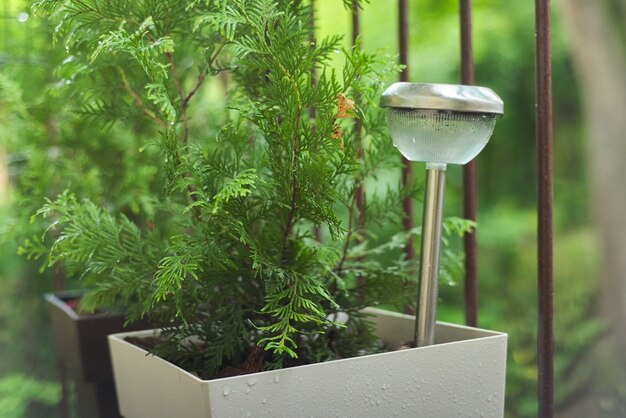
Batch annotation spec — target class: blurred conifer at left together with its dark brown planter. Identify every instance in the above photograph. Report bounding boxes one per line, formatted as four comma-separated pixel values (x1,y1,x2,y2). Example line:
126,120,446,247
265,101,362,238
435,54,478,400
0,5,161,417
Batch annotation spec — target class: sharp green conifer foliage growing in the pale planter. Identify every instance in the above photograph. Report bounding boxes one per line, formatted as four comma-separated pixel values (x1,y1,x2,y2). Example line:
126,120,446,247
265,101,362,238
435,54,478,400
26,0,471,376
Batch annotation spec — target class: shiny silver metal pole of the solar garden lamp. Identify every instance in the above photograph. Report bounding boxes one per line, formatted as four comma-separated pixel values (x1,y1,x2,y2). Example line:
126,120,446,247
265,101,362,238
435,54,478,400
415,163,446,347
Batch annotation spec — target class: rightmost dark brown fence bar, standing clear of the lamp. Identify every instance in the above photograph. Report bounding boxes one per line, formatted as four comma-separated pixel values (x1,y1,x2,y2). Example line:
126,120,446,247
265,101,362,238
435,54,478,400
535,0,554,418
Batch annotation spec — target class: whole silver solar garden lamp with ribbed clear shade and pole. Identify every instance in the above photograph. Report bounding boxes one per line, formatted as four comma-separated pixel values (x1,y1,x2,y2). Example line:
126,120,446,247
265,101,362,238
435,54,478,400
380,83,504,347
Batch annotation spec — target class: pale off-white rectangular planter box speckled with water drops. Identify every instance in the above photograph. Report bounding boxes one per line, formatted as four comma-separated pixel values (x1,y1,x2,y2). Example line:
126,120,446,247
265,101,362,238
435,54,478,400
109,309,507,418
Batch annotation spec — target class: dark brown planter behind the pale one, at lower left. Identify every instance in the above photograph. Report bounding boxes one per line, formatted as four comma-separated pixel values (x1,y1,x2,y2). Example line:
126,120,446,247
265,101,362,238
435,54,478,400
45,291,149,418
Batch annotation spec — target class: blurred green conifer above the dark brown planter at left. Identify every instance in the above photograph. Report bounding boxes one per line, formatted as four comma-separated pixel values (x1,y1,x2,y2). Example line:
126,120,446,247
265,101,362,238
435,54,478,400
0,8,161,288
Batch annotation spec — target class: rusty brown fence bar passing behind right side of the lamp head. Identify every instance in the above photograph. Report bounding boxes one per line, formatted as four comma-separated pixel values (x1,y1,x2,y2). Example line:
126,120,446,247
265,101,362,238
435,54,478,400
459,0,478,327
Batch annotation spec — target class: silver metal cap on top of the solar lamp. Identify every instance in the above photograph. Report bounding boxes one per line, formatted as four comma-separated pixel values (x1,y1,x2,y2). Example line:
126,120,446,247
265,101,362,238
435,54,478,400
380,82,504,115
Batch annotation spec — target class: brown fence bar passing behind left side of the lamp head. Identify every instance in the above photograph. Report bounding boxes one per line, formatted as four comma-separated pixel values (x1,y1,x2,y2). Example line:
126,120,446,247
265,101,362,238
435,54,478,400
398,0,415,259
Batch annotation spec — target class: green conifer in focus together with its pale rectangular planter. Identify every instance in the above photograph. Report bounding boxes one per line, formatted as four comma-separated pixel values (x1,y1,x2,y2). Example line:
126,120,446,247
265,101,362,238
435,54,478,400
30,0,506,417
